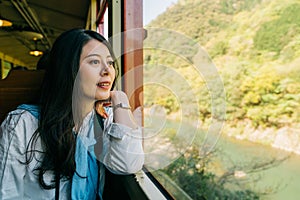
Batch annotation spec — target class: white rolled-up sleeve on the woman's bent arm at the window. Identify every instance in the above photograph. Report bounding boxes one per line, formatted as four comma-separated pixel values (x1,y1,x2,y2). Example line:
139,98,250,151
104,123,144,174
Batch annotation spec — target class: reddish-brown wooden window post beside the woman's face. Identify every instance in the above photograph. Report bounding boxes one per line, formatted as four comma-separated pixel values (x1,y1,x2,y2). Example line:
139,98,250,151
123,0,144,108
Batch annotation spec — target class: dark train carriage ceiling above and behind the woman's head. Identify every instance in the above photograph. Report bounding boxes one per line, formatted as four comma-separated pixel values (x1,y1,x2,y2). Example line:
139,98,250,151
0,0,91,67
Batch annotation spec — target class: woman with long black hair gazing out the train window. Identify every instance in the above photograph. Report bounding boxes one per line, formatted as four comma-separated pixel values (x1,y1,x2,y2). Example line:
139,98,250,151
0,29,144,199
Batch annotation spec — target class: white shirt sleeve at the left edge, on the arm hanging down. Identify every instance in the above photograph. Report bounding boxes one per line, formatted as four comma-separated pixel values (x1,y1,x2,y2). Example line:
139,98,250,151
0,113,26,199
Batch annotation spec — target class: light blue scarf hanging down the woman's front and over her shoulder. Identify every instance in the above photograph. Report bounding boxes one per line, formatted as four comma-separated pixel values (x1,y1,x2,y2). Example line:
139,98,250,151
17,104,104,200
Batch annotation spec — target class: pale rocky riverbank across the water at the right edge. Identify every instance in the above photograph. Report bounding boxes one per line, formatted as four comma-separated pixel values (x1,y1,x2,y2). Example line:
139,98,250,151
223,121,300,155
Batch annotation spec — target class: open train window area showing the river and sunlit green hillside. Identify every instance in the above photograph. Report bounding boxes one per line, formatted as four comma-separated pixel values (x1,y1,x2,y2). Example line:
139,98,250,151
143,0,300,199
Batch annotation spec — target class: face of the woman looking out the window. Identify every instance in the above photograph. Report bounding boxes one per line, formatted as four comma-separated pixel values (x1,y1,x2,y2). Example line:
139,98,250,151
79,39,116,100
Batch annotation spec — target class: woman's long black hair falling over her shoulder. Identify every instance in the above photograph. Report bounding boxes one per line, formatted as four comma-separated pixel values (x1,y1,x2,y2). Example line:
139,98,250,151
26,29,117,189
